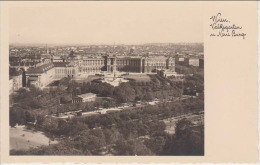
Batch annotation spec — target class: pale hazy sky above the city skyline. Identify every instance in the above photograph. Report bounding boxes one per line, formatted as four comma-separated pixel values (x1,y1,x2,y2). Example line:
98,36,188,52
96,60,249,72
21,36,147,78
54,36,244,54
9,1,203,44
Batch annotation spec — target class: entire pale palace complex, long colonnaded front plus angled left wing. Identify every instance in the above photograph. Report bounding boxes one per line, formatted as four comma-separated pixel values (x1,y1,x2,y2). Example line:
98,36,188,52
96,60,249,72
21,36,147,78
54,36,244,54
22,55,175,88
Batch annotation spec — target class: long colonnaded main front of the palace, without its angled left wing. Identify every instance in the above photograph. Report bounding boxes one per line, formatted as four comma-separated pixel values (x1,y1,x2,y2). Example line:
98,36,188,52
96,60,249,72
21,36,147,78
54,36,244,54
77,56,175,73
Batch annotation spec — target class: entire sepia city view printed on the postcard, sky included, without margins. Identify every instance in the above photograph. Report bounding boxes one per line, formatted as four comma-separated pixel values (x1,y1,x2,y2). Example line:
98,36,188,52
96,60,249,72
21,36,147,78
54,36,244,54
8,1,206,157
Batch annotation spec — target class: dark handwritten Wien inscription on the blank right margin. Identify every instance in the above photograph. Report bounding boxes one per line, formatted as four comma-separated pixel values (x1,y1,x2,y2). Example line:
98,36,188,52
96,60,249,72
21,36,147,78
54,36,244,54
210,13,246,39
